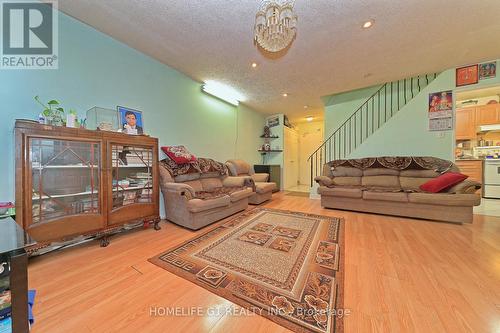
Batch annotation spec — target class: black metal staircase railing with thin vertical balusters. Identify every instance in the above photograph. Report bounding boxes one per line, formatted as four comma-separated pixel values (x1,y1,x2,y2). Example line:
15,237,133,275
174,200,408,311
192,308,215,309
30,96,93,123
307,73,438,187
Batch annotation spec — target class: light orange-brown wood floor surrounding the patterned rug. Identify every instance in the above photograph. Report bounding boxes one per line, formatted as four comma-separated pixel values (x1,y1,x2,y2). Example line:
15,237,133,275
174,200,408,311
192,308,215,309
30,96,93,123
29,194,500,333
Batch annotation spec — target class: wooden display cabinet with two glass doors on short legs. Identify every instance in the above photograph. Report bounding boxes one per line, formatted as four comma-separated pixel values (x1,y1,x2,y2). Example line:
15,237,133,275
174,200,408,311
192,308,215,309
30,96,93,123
15,120,160,246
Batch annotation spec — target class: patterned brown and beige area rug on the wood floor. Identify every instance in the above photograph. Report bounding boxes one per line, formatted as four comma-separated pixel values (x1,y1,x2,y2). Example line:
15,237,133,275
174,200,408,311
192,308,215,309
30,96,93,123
150,208,344,332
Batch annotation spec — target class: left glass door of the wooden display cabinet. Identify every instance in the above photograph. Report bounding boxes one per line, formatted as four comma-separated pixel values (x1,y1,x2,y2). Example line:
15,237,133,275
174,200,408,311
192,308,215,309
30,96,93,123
29,138,102,225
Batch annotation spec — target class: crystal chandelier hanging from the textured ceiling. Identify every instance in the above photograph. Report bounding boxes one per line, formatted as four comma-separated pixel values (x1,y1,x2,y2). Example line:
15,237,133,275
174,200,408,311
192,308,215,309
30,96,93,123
254,0,297,52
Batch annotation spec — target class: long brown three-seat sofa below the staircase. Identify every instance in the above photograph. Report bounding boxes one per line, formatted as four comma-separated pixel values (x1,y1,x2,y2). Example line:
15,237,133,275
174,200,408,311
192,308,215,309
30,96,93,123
315,156,481,223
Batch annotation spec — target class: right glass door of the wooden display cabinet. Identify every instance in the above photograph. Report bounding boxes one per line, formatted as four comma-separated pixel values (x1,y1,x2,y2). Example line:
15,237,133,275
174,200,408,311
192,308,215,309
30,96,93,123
111,144,153,211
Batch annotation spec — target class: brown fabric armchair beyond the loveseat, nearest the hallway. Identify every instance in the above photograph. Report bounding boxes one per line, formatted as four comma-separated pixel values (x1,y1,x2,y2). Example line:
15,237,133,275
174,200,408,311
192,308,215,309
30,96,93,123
226,159,276,205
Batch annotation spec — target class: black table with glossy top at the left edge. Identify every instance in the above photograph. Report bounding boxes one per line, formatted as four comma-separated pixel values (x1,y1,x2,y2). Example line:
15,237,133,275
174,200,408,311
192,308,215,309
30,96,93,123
0,217,29,333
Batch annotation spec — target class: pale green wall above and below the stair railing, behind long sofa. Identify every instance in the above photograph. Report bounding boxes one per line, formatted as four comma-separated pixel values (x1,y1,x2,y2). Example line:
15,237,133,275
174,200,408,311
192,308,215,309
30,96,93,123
325,62,500,160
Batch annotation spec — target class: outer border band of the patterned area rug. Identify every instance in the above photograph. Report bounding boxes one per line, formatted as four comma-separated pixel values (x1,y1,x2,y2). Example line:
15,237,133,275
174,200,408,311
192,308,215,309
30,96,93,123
148,207,345,333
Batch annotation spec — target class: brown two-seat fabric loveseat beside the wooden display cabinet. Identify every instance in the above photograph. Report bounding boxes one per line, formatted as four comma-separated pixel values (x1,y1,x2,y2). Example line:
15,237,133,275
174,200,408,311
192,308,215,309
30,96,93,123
159,158,253,230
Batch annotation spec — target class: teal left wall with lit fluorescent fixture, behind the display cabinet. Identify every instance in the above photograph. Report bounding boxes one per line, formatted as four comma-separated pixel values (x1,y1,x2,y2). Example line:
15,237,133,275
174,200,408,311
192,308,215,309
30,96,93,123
0,14,265,213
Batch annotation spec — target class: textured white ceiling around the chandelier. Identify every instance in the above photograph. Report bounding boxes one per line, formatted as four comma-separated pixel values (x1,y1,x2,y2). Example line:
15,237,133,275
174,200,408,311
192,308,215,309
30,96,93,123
59,0,500,121
